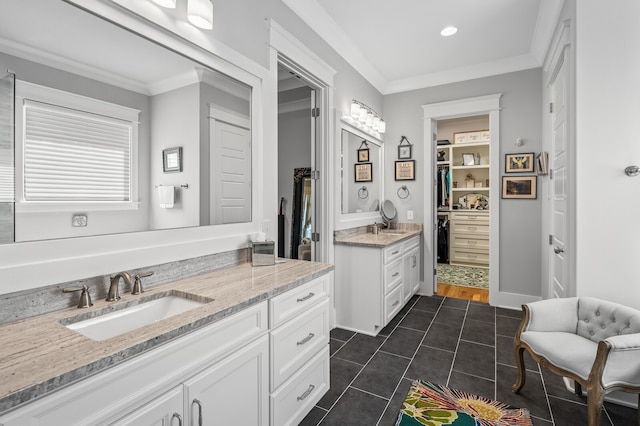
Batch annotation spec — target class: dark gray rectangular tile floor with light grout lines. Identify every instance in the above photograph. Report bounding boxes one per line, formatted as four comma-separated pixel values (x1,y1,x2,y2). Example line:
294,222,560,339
301,296,637,426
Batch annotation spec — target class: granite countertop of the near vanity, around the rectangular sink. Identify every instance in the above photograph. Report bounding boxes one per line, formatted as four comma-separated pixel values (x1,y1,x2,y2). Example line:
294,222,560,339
0,259,333,413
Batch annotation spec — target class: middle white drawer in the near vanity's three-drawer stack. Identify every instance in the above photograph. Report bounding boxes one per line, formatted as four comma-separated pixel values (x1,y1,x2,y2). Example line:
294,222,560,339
270,298,329,391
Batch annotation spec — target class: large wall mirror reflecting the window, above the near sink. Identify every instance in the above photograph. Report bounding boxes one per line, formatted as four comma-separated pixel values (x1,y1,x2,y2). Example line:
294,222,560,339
0,0,252,243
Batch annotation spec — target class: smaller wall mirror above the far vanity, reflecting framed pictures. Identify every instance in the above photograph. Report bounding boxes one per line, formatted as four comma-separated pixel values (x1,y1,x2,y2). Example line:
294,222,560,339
339,118,384,227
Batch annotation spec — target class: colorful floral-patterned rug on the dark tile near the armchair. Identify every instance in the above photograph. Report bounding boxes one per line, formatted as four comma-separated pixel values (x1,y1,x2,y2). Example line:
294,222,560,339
396,380,532,426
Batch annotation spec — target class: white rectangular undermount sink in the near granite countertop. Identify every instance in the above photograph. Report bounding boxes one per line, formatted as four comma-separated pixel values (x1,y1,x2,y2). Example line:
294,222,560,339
61,291,213,341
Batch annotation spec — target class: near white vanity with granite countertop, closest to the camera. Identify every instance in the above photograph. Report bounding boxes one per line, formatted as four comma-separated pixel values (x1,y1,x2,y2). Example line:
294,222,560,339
0,260,333,426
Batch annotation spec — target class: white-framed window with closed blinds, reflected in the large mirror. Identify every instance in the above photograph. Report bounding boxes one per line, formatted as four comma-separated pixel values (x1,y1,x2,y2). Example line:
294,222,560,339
16,81,139,210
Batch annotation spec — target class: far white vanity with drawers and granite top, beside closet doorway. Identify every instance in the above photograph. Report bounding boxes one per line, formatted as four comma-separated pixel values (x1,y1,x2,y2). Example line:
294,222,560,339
335,227,422,336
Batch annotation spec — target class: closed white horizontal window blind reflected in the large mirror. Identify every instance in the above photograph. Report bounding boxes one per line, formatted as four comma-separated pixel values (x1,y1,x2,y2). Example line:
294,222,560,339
23,99,132,202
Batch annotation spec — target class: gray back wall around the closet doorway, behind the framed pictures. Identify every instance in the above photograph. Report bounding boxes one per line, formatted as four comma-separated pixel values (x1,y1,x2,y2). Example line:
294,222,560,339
384,69,542,296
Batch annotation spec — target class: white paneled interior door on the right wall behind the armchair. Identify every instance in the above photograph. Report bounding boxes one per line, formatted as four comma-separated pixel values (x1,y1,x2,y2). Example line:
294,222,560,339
549,57,573,297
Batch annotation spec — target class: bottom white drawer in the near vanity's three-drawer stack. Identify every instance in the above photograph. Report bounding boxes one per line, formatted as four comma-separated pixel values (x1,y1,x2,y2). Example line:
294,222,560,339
271,345,329,426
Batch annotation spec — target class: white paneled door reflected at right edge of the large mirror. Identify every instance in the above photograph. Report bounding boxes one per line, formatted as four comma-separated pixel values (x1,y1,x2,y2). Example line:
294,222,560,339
209,108,251,224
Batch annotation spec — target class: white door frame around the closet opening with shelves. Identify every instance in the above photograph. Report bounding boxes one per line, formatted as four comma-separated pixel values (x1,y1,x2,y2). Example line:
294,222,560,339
419,93,502,306
